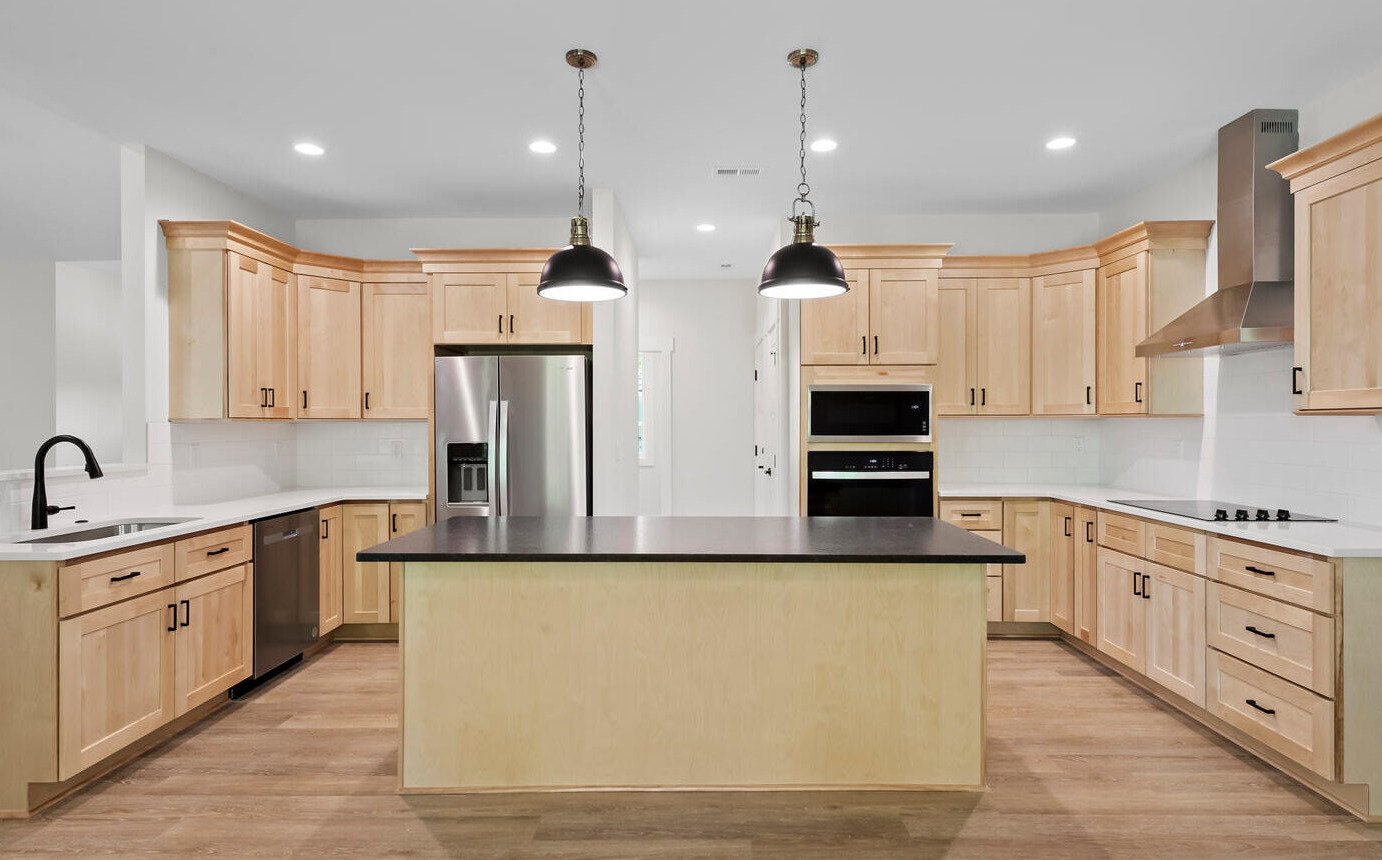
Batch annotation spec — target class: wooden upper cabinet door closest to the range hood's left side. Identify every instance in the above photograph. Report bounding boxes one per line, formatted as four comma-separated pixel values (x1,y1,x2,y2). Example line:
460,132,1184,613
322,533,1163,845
1095,253,1148,415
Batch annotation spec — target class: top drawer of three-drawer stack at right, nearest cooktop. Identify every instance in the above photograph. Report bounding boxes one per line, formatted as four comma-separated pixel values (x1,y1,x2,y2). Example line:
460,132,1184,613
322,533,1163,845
1209,536,1334,615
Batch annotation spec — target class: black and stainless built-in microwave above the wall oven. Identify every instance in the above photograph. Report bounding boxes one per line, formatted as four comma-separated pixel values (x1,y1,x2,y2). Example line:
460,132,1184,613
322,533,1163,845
806,383,931,442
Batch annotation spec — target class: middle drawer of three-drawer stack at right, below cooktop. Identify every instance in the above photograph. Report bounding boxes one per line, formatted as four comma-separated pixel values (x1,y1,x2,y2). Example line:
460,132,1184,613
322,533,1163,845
1206,582,1334,698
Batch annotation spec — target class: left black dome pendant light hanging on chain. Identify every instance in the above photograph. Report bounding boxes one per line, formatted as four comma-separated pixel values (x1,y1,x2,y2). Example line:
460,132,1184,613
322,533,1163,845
538,48,629,301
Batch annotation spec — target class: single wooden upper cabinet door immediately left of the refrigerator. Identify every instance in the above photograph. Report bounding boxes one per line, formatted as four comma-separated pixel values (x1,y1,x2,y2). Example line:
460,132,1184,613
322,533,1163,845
361,283,433,420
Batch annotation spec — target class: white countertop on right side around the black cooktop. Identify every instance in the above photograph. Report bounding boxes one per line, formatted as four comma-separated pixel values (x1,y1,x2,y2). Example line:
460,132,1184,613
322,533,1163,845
940,484,1382,559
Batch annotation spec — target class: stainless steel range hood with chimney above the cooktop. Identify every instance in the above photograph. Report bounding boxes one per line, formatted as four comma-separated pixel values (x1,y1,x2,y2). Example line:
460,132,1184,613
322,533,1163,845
1137,109,1300,355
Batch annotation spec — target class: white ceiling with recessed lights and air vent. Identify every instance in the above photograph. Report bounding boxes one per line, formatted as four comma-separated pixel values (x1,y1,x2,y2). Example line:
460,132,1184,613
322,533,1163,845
0,0,1382,277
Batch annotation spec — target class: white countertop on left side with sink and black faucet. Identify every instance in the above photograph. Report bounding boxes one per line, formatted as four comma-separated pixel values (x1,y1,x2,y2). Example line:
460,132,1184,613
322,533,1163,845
0,487,427,561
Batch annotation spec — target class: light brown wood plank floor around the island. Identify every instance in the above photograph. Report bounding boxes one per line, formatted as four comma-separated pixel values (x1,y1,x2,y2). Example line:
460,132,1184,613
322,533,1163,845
0,642,1382,860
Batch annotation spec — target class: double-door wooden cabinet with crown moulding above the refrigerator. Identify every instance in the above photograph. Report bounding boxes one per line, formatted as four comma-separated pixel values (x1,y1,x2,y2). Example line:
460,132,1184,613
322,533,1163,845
413,247,591,346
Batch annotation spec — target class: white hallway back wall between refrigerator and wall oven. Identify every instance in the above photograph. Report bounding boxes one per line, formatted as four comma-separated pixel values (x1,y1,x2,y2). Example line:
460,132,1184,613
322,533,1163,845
638,279,757,516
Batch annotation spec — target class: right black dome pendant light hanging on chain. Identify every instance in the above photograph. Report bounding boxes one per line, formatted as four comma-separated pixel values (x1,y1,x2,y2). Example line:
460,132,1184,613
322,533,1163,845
759,48,850,299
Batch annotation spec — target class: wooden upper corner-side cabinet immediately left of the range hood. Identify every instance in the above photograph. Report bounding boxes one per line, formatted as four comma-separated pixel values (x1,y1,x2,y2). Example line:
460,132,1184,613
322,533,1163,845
1095,221,1213,415
